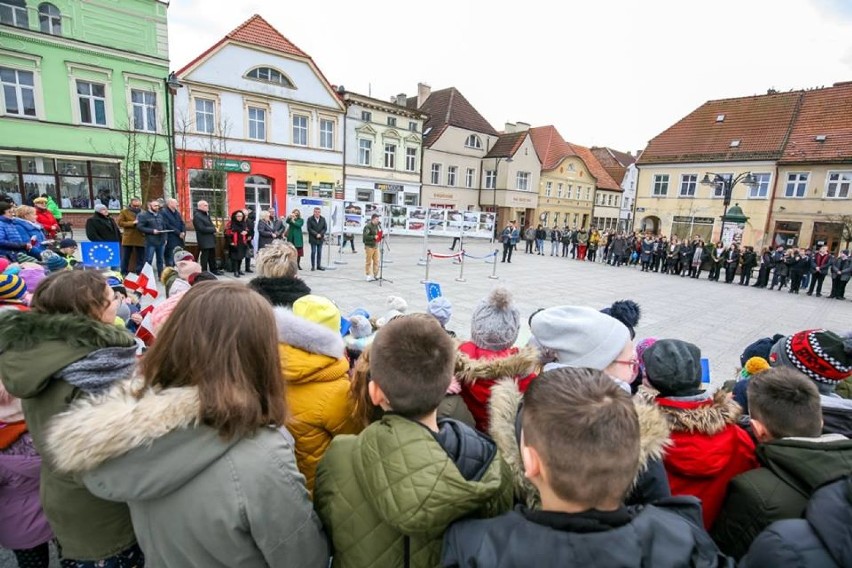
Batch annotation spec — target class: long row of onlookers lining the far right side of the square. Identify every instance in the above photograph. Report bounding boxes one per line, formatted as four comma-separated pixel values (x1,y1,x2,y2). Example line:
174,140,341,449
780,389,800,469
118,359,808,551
512,222,852,300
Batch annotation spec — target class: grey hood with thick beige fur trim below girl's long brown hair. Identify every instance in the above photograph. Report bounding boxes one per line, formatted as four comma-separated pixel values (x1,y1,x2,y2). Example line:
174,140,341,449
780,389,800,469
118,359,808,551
46,381,239,501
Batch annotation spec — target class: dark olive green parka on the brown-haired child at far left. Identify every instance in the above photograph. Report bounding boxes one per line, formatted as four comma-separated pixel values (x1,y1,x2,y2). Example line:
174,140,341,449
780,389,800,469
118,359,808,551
0,312,136,560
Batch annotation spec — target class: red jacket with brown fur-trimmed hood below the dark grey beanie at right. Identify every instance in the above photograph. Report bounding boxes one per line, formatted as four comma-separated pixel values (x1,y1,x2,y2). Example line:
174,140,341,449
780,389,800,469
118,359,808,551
656,393,758,530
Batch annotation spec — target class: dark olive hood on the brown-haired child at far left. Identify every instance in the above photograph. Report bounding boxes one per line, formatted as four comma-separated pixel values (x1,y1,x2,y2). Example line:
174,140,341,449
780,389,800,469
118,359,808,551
0,310,136,399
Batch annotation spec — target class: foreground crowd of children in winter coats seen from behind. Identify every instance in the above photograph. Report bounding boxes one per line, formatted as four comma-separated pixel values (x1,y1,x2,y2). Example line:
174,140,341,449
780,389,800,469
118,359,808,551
0,225,852,568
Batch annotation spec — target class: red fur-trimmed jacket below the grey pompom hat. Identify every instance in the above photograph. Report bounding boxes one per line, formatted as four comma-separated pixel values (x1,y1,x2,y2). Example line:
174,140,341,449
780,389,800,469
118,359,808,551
459,341,536,433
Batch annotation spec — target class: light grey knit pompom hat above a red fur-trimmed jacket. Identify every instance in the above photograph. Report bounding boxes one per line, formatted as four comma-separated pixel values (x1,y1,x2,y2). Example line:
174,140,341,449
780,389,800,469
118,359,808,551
470,287,521,351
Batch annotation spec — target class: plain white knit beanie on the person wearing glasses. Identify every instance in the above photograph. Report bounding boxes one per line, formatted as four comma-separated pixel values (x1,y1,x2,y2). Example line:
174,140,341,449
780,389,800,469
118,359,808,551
530,306,630,371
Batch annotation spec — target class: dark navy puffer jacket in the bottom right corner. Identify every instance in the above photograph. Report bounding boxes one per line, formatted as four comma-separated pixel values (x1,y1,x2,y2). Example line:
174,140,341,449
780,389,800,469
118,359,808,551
740,477,852,568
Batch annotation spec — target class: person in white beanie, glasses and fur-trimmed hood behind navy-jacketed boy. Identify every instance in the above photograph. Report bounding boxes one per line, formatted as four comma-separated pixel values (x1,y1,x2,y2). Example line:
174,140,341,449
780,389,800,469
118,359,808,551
489,306,671,506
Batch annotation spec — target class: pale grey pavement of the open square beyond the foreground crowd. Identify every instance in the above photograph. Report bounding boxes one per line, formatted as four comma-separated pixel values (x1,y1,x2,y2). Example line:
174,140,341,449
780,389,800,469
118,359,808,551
0,236,852,568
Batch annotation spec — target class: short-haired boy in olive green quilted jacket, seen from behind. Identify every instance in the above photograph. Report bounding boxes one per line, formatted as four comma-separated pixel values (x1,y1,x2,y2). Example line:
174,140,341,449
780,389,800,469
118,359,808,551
314,315,512,568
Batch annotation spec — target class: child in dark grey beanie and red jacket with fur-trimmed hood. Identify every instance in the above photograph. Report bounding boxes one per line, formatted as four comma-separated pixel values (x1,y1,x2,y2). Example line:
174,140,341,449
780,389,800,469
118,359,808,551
644,339,757,530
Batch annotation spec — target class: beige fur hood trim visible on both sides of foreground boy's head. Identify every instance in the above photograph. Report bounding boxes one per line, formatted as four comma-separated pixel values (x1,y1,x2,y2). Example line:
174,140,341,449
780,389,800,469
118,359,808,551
489,380,670,508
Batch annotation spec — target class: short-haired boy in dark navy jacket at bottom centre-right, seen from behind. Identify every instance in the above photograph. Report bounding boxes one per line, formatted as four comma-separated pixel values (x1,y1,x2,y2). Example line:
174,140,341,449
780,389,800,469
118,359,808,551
442,367,730,568
